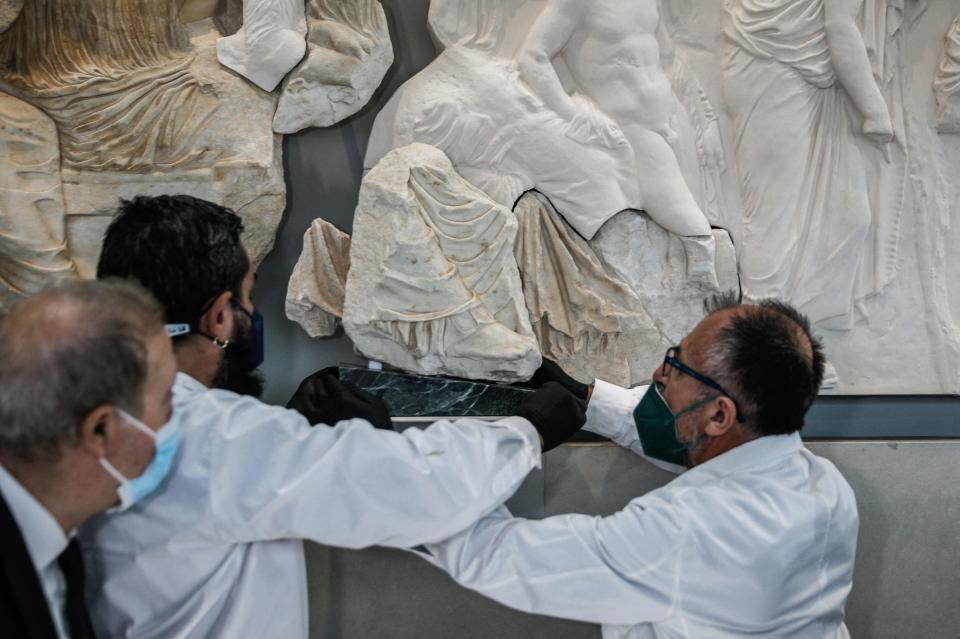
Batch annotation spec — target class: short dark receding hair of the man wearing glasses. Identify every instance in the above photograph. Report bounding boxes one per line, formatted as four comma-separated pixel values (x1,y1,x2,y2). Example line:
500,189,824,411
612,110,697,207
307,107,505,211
704,293,825,436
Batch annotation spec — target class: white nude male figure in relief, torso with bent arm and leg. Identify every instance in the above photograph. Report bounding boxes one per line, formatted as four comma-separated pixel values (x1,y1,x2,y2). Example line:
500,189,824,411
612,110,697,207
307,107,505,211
518,0,713,284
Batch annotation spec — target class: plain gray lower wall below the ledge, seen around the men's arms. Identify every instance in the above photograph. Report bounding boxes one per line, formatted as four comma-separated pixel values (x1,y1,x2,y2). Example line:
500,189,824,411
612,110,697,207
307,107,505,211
307,441,960,639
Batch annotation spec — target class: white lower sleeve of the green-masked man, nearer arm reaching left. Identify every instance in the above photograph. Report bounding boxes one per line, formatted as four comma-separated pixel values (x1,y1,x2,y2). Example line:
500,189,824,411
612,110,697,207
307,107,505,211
418,504,686,624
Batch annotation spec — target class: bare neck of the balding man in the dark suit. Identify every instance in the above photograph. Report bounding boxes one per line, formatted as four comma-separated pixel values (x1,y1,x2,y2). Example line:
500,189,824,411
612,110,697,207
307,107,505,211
0,456,96,535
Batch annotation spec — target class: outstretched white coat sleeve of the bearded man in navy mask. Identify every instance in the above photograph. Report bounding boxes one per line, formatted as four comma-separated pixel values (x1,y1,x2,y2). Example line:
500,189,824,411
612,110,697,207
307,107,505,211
209,400,540,548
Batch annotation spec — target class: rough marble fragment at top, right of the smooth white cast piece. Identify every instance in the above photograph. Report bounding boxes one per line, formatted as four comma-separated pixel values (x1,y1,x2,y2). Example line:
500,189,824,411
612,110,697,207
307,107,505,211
273,0,393,133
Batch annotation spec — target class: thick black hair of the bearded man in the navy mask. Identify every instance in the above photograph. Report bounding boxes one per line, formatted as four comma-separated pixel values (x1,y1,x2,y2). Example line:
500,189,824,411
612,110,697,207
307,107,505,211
97,195,249,328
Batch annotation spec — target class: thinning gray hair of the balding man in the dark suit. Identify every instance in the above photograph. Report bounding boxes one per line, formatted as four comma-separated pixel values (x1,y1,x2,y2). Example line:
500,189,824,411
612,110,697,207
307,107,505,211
0,280,163,462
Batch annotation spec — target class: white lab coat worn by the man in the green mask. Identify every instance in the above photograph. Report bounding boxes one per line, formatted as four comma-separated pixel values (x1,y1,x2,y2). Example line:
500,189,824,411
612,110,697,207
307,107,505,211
427,382,858,639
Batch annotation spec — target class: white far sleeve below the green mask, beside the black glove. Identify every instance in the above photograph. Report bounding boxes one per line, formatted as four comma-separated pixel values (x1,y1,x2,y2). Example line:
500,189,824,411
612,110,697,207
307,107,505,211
583,379,685,473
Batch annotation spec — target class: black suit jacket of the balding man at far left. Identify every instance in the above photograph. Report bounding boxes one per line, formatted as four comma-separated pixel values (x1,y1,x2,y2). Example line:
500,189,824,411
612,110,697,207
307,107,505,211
0,493,93,639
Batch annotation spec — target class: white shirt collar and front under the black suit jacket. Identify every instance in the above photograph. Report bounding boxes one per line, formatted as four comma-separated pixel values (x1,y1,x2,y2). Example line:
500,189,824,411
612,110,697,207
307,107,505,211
0,465,70,639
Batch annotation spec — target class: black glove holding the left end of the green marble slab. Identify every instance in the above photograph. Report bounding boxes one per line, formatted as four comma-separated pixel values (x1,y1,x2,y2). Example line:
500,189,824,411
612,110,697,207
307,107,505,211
287,366,393,430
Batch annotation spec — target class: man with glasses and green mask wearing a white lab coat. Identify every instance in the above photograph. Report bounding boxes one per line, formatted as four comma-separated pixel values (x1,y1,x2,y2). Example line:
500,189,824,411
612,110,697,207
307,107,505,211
426,295,858,639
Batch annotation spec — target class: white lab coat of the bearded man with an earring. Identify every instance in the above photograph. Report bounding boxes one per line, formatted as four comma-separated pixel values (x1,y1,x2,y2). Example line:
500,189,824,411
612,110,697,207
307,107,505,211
82,374,540,639
